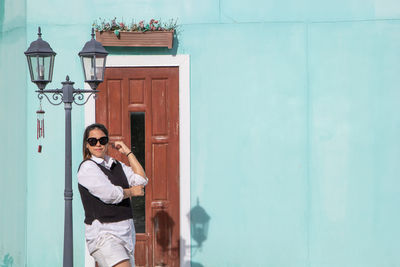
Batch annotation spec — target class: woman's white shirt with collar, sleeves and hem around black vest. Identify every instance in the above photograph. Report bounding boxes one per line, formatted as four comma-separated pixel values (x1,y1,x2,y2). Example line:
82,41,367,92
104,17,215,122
78,156,148,255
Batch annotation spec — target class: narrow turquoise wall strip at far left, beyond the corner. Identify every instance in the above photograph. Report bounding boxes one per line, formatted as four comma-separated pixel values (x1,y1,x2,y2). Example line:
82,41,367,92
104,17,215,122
0,0,27,267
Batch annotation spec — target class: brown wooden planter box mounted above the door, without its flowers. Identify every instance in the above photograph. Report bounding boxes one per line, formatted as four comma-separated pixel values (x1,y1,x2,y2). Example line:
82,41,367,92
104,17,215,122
96,31,174,49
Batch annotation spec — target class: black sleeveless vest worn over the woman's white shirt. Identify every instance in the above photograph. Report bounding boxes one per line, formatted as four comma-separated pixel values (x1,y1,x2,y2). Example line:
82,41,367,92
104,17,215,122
78,160,133,224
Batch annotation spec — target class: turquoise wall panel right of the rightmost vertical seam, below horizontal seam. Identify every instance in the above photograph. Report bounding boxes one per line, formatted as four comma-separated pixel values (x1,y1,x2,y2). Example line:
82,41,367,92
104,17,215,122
309,21,400,267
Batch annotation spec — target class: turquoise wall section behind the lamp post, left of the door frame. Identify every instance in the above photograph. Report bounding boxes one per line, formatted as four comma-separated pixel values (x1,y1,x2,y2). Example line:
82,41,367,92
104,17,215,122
27,26,90,266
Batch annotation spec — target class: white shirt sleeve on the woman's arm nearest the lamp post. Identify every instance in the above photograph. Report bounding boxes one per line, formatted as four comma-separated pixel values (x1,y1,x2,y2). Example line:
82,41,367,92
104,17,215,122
78,160,124,204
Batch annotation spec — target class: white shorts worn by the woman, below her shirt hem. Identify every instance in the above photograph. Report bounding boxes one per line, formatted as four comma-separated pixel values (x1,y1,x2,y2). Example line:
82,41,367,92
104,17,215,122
92,234,135,267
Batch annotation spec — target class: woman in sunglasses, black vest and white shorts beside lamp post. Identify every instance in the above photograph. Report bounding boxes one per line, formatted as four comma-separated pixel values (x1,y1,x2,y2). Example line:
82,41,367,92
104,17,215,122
78,124,148,267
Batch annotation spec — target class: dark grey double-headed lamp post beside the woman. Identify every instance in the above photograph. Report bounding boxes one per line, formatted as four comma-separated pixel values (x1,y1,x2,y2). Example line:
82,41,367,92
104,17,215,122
25,27,108,267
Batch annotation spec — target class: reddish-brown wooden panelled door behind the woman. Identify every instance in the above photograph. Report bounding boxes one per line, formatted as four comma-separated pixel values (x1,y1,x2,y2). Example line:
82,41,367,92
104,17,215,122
96,67,180,267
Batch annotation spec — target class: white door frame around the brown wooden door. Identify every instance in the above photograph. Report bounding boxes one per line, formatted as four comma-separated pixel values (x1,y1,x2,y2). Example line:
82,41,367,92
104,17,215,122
85,55,191,267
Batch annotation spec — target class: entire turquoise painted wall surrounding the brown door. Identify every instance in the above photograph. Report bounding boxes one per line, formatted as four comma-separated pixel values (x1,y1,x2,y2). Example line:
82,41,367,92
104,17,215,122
0,0,400,267
